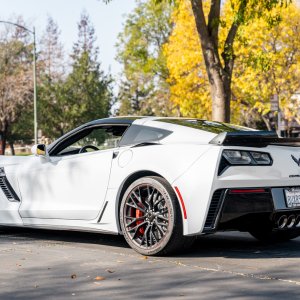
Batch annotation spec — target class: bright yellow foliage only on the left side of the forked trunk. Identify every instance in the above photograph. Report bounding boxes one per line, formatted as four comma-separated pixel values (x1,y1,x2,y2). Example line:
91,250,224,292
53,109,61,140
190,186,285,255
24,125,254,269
164,1,211,119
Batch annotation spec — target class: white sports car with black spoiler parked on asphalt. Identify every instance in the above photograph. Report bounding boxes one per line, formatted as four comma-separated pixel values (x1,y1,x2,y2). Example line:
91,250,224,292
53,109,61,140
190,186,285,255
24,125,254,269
0,117,300,255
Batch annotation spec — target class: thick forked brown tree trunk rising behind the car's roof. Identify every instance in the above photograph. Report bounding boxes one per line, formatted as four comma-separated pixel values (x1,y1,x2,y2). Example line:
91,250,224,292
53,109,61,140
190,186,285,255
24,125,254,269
190,0,249,123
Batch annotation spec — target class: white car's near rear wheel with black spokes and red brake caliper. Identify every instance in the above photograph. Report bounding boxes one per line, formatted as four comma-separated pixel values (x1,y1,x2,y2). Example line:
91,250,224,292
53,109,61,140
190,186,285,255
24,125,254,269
120,176,194,256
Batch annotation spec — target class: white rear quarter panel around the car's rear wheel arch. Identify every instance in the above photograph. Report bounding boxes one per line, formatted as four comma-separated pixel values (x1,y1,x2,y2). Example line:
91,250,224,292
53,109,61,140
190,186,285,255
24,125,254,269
101,144,217,234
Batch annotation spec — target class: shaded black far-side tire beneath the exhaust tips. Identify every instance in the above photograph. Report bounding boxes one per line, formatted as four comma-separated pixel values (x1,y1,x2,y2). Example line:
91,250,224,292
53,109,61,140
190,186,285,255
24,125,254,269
249,228,300,243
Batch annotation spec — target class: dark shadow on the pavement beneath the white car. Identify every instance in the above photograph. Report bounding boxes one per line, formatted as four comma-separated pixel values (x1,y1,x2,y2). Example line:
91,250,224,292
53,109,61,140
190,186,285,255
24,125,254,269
0,227,300,259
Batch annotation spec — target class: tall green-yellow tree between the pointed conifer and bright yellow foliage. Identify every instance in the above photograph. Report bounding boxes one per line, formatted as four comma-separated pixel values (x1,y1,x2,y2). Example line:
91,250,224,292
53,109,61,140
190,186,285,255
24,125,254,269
117,0,173,115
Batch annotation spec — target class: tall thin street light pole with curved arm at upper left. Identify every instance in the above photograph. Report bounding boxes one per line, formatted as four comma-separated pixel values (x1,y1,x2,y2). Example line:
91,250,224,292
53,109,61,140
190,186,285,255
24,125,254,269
0,21,38,144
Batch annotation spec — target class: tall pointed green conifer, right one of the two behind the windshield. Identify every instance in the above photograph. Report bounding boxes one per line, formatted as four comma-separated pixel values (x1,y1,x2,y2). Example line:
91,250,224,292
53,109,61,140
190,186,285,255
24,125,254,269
62,13,112,132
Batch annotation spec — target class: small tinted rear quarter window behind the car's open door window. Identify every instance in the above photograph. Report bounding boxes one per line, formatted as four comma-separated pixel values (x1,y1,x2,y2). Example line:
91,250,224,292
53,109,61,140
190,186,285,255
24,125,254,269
119,125,172,146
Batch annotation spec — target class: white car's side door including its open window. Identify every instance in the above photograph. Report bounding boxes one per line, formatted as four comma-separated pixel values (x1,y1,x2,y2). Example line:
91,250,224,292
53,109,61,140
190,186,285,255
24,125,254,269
18,123,126,220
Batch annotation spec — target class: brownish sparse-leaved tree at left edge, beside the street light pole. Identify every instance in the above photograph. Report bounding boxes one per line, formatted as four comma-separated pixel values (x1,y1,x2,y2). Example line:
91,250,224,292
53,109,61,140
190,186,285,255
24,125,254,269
0,18,33,154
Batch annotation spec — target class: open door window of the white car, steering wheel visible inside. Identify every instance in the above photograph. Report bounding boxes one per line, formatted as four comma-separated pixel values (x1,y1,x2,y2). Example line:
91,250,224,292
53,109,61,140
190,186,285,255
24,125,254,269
52,125,127,156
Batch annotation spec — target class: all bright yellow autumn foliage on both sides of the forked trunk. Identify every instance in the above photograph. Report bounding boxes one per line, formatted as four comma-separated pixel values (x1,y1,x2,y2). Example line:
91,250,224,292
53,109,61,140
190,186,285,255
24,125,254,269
164,0,300,126
